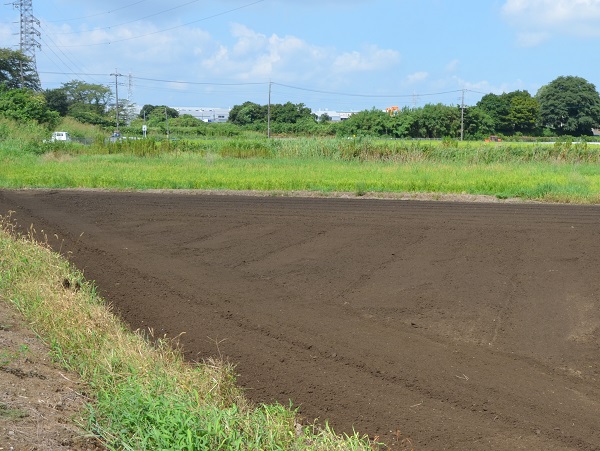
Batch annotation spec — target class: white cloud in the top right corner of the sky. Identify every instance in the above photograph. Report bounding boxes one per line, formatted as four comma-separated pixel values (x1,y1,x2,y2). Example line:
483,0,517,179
502,0,600,42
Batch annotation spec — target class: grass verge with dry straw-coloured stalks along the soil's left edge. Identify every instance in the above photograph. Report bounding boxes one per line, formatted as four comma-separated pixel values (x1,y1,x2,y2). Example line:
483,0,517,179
0,218,376,450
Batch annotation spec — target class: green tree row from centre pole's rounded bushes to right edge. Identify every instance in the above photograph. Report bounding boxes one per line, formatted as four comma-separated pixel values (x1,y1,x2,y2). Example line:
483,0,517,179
229,76,600,139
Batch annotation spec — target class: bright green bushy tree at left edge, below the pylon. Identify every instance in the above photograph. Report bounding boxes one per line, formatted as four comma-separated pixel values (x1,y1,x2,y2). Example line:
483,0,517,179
0,84,60,128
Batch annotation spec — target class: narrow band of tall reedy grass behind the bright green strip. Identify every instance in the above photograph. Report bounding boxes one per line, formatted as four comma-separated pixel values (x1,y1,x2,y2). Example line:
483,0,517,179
78,138,600,164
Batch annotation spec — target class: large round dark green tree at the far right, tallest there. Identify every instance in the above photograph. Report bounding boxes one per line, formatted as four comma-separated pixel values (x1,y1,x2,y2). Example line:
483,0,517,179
536,76,600,136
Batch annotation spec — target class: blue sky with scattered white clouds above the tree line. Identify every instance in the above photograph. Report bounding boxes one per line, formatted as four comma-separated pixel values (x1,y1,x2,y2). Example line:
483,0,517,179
0,0,600,110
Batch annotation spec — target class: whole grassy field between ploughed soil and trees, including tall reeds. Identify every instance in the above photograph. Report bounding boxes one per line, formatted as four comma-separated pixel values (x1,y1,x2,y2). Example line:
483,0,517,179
0,132,600,203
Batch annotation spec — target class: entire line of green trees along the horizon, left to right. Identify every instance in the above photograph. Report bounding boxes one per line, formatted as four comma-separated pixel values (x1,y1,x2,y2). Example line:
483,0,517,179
0,48,600,139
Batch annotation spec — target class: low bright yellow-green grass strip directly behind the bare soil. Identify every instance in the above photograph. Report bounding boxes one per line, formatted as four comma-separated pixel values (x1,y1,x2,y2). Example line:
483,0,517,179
0,147,600,203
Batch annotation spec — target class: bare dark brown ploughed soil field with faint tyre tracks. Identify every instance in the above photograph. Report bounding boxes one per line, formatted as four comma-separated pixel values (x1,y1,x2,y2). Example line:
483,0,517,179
0,191,600,450
